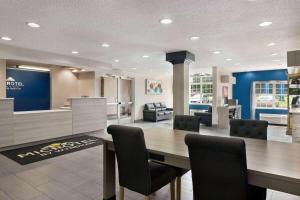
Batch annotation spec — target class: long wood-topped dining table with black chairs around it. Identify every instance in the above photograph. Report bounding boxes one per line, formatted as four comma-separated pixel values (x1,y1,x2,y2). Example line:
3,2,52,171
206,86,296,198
101,128,300,200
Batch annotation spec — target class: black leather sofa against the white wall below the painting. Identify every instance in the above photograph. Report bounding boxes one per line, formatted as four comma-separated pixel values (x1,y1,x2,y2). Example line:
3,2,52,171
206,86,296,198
143,103,173,122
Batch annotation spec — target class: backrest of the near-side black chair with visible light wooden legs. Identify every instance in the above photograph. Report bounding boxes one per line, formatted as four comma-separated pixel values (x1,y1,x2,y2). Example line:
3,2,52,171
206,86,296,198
107,125,151,194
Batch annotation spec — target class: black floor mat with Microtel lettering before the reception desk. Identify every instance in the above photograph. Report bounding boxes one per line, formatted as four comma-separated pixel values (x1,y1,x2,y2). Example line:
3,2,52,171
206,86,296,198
1,135,102,165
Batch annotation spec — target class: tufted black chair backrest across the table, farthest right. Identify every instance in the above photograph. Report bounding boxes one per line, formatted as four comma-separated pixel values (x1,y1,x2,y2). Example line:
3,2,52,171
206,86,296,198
230,119,268,140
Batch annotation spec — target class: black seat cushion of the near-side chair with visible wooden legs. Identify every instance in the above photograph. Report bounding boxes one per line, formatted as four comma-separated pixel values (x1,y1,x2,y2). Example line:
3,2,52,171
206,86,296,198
149,161,176,193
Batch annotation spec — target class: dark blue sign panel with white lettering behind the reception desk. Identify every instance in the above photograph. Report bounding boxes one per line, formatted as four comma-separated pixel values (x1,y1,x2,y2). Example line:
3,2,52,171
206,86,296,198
6,69,50,111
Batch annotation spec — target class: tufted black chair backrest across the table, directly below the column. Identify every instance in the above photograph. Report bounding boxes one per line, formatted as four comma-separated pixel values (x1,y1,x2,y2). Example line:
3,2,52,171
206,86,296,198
173,115,200,132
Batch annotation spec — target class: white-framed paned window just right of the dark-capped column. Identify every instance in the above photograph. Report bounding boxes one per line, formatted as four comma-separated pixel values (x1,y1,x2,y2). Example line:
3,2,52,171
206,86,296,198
190,74,213,104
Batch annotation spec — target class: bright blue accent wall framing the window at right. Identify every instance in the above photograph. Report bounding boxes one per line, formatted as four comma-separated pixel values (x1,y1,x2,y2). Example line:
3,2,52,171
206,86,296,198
232,69,288,119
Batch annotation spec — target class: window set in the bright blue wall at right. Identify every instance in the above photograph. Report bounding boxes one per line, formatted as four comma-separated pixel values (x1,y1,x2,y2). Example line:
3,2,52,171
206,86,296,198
254,81,287,108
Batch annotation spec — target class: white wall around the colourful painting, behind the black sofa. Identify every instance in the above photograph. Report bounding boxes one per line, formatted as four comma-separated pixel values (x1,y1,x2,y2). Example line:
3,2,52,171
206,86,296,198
133,75,173,120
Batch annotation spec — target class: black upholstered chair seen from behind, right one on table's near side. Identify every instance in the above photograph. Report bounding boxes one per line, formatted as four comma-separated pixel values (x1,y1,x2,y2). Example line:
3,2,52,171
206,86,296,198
185,134,266,200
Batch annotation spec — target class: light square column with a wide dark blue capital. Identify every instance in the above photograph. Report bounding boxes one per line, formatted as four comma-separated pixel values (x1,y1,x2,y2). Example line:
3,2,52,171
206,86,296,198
166,51,195,115
